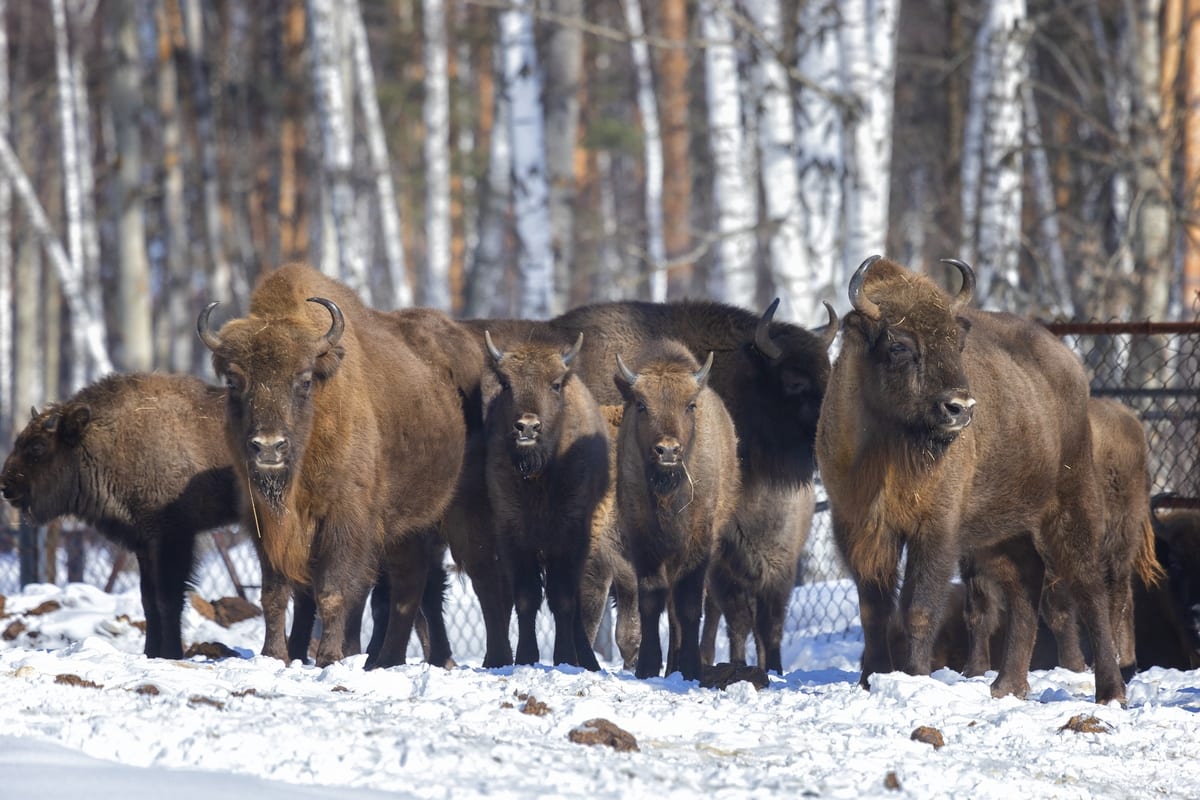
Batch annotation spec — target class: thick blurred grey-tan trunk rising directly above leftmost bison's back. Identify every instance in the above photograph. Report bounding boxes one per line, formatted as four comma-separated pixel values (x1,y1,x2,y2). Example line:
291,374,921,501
108,0,154,372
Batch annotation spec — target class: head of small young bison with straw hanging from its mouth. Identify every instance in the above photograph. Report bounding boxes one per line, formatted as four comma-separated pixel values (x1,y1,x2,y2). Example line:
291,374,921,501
614,342,713,493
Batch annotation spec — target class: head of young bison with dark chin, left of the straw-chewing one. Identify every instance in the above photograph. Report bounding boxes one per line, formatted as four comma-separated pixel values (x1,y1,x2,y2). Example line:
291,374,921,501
484,331,583,477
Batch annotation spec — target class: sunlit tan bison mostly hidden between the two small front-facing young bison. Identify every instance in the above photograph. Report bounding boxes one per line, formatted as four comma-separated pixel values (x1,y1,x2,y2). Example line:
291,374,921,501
580,405,642,669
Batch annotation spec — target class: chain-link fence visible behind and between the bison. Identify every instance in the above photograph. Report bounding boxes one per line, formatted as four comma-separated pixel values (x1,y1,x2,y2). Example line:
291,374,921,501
0,323,1200,658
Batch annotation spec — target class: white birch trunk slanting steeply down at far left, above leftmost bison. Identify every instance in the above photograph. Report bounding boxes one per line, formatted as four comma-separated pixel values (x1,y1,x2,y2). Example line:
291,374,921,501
0,137,113,374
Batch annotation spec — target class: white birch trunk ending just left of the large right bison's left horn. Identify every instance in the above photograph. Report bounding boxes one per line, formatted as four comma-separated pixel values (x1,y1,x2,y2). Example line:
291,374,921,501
792,0,850,311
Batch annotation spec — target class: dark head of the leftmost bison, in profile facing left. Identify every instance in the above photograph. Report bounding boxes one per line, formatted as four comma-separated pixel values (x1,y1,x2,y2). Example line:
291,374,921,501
0,402,91,523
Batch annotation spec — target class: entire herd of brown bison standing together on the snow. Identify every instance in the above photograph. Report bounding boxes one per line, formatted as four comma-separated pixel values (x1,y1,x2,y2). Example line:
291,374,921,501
0,257,1200,703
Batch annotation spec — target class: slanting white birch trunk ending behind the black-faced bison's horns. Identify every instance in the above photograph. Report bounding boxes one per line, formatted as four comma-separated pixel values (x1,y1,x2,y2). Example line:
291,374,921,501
745,0,801,324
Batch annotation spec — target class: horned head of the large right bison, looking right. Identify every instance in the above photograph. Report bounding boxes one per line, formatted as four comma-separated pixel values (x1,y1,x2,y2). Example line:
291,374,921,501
846,255,974,452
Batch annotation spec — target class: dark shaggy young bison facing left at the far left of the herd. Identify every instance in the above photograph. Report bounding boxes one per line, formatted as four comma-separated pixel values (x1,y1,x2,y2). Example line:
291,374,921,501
0,374,238,658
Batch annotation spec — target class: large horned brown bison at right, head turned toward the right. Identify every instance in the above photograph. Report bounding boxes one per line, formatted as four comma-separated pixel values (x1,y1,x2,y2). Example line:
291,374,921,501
817,257,1124,703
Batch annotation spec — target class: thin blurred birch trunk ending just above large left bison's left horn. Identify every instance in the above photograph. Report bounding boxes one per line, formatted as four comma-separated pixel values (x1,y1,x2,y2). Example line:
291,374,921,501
180,0,242,306
